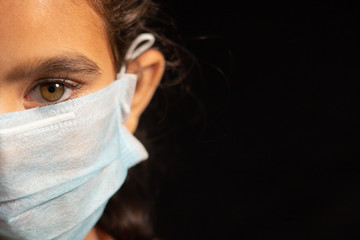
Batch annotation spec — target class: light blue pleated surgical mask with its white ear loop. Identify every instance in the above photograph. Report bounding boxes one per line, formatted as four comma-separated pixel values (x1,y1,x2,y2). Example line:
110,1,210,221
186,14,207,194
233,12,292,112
0,34,153,240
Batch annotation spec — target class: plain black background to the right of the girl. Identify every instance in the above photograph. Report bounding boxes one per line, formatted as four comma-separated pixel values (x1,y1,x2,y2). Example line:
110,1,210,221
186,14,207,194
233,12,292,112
153,0,360,240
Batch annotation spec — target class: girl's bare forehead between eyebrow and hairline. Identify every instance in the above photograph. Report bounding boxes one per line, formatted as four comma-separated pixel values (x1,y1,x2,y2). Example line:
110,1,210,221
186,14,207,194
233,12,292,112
0,0,108,74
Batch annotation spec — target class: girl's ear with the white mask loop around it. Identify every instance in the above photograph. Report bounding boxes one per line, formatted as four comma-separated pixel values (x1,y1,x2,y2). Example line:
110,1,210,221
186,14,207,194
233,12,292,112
125,49,165,133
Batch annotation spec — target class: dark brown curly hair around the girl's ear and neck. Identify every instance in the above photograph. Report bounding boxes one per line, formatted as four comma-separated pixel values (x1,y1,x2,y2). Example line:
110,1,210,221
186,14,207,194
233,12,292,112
88,0,199,240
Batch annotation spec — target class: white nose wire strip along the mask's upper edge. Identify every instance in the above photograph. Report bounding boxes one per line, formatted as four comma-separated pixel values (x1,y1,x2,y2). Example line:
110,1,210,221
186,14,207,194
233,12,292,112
0,112,75,136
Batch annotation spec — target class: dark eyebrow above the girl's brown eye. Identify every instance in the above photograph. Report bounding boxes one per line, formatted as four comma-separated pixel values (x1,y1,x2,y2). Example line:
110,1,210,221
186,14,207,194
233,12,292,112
6,53,101,81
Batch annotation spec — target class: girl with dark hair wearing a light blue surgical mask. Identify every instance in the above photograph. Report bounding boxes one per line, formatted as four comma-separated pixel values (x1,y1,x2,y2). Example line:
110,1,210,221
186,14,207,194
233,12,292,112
0,0,198,240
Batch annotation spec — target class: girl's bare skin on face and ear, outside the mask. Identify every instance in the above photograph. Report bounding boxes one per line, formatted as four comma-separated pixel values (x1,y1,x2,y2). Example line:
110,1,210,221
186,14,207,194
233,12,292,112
0,0,165,240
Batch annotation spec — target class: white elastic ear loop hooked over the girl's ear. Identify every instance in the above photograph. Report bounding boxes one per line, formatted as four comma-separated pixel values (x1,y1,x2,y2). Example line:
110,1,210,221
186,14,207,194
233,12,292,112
118,33,155,75
